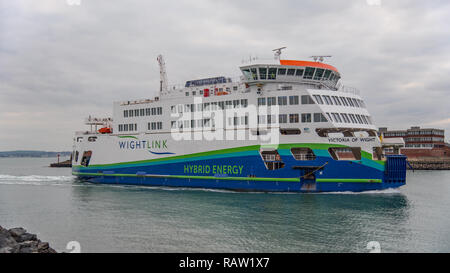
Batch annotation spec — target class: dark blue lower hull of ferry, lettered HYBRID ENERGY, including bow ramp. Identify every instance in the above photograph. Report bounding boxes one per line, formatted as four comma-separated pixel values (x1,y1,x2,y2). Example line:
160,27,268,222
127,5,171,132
73,153,406,192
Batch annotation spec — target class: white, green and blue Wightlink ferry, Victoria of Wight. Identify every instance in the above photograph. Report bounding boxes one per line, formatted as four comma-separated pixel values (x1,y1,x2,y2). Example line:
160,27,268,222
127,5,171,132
72,48,406,193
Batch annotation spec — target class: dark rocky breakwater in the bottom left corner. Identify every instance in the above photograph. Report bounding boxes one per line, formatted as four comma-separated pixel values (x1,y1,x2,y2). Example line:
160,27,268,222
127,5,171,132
0,226,56,253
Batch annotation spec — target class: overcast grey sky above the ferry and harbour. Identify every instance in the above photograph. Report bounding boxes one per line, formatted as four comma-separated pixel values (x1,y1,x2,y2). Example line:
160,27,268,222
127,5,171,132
0,0,450,151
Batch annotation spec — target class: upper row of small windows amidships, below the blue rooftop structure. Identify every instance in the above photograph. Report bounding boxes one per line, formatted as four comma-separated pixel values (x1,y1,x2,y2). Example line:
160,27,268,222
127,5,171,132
170,99,248,114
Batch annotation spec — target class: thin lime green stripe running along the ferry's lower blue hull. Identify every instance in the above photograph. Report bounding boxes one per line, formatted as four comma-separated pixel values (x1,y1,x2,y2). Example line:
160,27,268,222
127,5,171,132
72,172,382,183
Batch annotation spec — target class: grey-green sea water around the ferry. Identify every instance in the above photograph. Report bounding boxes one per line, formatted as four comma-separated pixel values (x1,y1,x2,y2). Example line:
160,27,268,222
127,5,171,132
0,158,450,252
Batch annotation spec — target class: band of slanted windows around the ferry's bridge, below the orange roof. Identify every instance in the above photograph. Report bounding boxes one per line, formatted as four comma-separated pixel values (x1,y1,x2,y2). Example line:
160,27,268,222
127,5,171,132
242,67,340,81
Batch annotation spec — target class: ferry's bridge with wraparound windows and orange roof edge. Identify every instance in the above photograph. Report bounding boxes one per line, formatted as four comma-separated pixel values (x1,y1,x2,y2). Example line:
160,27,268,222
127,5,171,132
240,60,341,89
